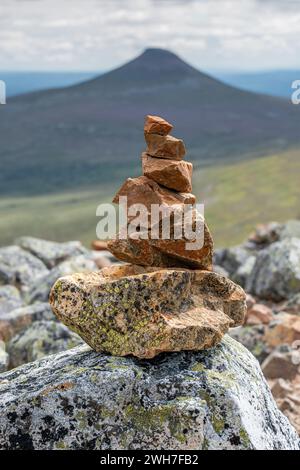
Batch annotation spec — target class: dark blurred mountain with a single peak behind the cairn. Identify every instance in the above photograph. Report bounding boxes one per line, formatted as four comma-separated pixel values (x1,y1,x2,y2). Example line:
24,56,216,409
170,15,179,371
0,49,300,195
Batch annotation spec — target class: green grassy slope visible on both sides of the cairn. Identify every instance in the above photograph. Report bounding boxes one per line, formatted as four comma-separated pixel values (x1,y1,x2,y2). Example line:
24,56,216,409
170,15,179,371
0,150,300,246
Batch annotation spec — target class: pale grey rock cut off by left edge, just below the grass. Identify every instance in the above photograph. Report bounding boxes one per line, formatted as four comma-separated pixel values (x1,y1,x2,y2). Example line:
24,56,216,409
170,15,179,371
0,245,48,291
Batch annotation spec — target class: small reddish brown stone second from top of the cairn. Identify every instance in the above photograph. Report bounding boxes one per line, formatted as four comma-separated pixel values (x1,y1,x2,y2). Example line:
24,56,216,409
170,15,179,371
145,134,186,160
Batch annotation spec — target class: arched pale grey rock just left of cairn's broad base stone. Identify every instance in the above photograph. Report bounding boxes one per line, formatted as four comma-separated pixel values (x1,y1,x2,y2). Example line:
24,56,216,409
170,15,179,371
27,255,98,303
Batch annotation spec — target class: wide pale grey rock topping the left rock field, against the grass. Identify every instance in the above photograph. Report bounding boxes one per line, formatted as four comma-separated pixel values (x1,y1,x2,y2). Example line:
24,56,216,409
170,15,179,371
15,237,88,269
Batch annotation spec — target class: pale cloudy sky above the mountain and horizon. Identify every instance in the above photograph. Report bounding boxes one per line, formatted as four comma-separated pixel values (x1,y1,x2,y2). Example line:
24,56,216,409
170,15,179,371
0,0,300,70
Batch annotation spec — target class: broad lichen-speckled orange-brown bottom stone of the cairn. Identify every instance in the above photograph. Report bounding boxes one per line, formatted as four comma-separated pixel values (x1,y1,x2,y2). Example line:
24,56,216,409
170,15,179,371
50,265,245,358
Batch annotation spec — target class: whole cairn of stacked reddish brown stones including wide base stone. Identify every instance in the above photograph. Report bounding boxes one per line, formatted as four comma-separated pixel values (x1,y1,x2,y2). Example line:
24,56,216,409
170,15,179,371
50,116,246,359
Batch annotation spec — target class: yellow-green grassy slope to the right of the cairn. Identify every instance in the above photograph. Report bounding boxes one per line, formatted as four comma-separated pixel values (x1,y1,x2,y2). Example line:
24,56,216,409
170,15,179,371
194,150,300,246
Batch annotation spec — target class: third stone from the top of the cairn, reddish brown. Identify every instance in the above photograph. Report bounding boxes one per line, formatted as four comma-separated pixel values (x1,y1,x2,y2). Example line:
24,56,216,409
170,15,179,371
142,153,193,193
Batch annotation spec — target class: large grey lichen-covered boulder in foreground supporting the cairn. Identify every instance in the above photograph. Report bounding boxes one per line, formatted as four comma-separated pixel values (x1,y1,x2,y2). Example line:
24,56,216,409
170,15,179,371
0,336,300,450
